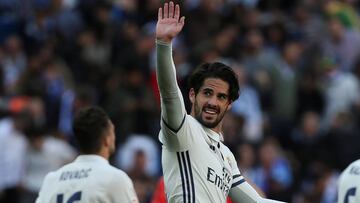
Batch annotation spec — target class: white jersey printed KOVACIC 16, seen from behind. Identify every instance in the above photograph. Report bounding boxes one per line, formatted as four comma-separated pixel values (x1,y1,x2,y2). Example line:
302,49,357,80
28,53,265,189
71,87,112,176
36,155,138,203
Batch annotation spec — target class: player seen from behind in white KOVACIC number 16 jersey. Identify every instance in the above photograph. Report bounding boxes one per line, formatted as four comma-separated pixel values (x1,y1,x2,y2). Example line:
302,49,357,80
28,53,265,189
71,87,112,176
36,107,138,203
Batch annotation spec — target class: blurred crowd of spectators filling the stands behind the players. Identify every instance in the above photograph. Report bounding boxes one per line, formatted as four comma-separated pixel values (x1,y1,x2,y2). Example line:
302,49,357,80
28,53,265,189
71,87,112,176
0,0,360,203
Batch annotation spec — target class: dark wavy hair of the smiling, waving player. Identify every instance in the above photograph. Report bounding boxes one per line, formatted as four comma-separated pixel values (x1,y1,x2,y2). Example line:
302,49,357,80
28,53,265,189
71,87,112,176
189,62,239,102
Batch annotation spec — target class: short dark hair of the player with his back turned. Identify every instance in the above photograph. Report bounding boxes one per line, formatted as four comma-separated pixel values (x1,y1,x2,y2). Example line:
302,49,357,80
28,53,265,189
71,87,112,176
73,106,110,154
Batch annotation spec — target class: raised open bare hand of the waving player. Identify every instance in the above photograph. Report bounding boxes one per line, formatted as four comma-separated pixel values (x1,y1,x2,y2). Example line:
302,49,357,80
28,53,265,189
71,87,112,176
156,1,185,43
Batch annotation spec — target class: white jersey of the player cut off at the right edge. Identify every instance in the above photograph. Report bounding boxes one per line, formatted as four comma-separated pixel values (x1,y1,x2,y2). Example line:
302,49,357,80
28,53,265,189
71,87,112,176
338,159,360,203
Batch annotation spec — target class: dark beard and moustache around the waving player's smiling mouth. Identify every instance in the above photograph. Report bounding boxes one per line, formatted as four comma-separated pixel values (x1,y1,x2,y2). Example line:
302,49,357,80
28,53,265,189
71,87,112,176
194,101,225,128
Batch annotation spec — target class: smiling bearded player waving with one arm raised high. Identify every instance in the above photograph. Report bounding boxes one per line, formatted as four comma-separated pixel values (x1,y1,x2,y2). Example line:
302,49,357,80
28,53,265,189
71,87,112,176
156,2,286,203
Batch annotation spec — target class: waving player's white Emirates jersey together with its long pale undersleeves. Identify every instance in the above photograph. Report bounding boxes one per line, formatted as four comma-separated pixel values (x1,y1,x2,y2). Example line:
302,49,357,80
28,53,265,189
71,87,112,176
156,41,286,203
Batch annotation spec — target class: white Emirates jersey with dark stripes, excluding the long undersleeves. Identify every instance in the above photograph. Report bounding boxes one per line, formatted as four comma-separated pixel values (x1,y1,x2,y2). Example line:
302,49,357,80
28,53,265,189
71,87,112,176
159,115,245,203
